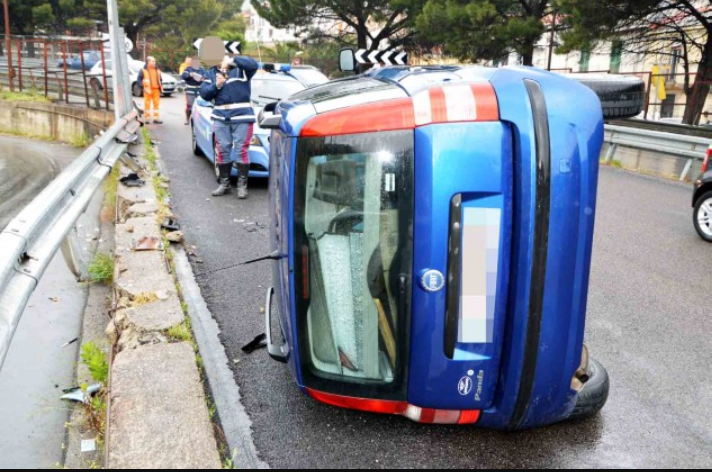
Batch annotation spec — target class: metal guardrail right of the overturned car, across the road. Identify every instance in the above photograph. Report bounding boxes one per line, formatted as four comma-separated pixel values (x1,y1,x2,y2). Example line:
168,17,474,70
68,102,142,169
604,125,712,180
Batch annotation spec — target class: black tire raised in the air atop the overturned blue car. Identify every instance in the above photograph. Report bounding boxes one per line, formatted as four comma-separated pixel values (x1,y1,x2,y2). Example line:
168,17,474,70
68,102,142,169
576,77,645,120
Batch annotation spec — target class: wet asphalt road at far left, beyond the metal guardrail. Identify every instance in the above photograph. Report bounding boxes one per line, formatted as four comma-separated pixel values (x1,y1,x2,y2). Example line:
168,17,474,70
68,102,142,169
0,136,87,469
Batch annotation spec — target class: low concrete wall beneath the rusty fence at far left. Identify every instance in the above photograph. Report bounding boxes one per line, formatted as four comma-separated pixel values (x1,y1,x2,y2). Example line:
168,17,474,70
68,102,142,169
0,101,114,143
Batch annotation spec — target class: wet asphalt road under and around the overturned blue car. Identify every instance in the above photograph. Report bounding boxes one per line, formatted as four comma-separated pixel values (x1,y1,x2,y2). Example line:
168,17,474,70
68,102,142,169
151,97,712,468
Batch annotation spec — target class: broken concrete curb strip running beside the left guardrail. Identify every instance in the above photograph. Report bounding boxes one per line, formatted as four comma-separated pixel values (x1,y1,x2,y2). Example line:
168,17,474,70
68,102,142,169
106,138,222,469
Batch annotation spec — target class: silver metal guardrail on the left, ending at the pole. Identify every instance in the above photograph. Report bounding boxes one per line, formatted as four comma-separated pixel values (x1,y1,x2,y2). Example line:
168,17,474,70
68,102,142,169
0,111,141,368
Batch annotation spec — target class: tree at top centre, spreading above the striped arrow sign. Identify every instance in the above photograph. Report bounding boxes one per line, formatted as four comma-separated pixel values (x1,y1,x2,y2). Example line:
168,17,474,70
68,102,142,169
253,0,425,50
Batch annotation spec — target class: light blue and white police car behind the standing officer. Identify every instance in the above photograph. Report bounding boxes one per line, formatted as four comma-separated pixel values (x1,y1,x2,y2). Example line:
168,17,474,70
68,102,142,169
191,64,328,178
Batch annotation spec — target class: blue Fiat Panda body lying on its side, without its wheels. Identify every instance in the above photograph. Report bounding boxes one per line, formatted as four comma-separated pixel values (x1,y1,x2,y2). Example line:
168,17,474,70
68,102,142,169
267,67,603,429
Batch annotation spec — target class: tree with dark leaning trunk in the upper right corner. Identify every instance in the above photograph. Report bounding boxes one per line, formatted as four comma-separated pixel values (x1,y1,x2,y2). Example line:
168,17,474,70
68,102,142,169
560,0,712,124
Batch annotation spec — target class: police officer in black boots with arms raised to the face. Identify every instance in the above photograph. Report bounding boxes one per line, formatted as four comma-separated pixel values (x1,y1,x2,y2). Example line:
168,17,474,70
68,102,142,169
200,56,259,199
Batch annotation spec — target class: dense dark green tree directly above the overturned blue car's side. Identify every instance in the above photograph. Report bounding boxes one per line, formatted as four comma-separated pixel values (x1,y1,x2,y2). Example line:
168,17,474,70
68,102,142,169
417,0,552,65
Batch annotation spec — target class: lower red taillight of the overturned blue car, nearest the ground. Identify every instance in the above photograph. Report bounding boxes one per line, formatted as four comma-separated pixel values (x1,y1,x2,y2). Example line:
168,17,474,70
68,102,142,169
307,389,481,425
